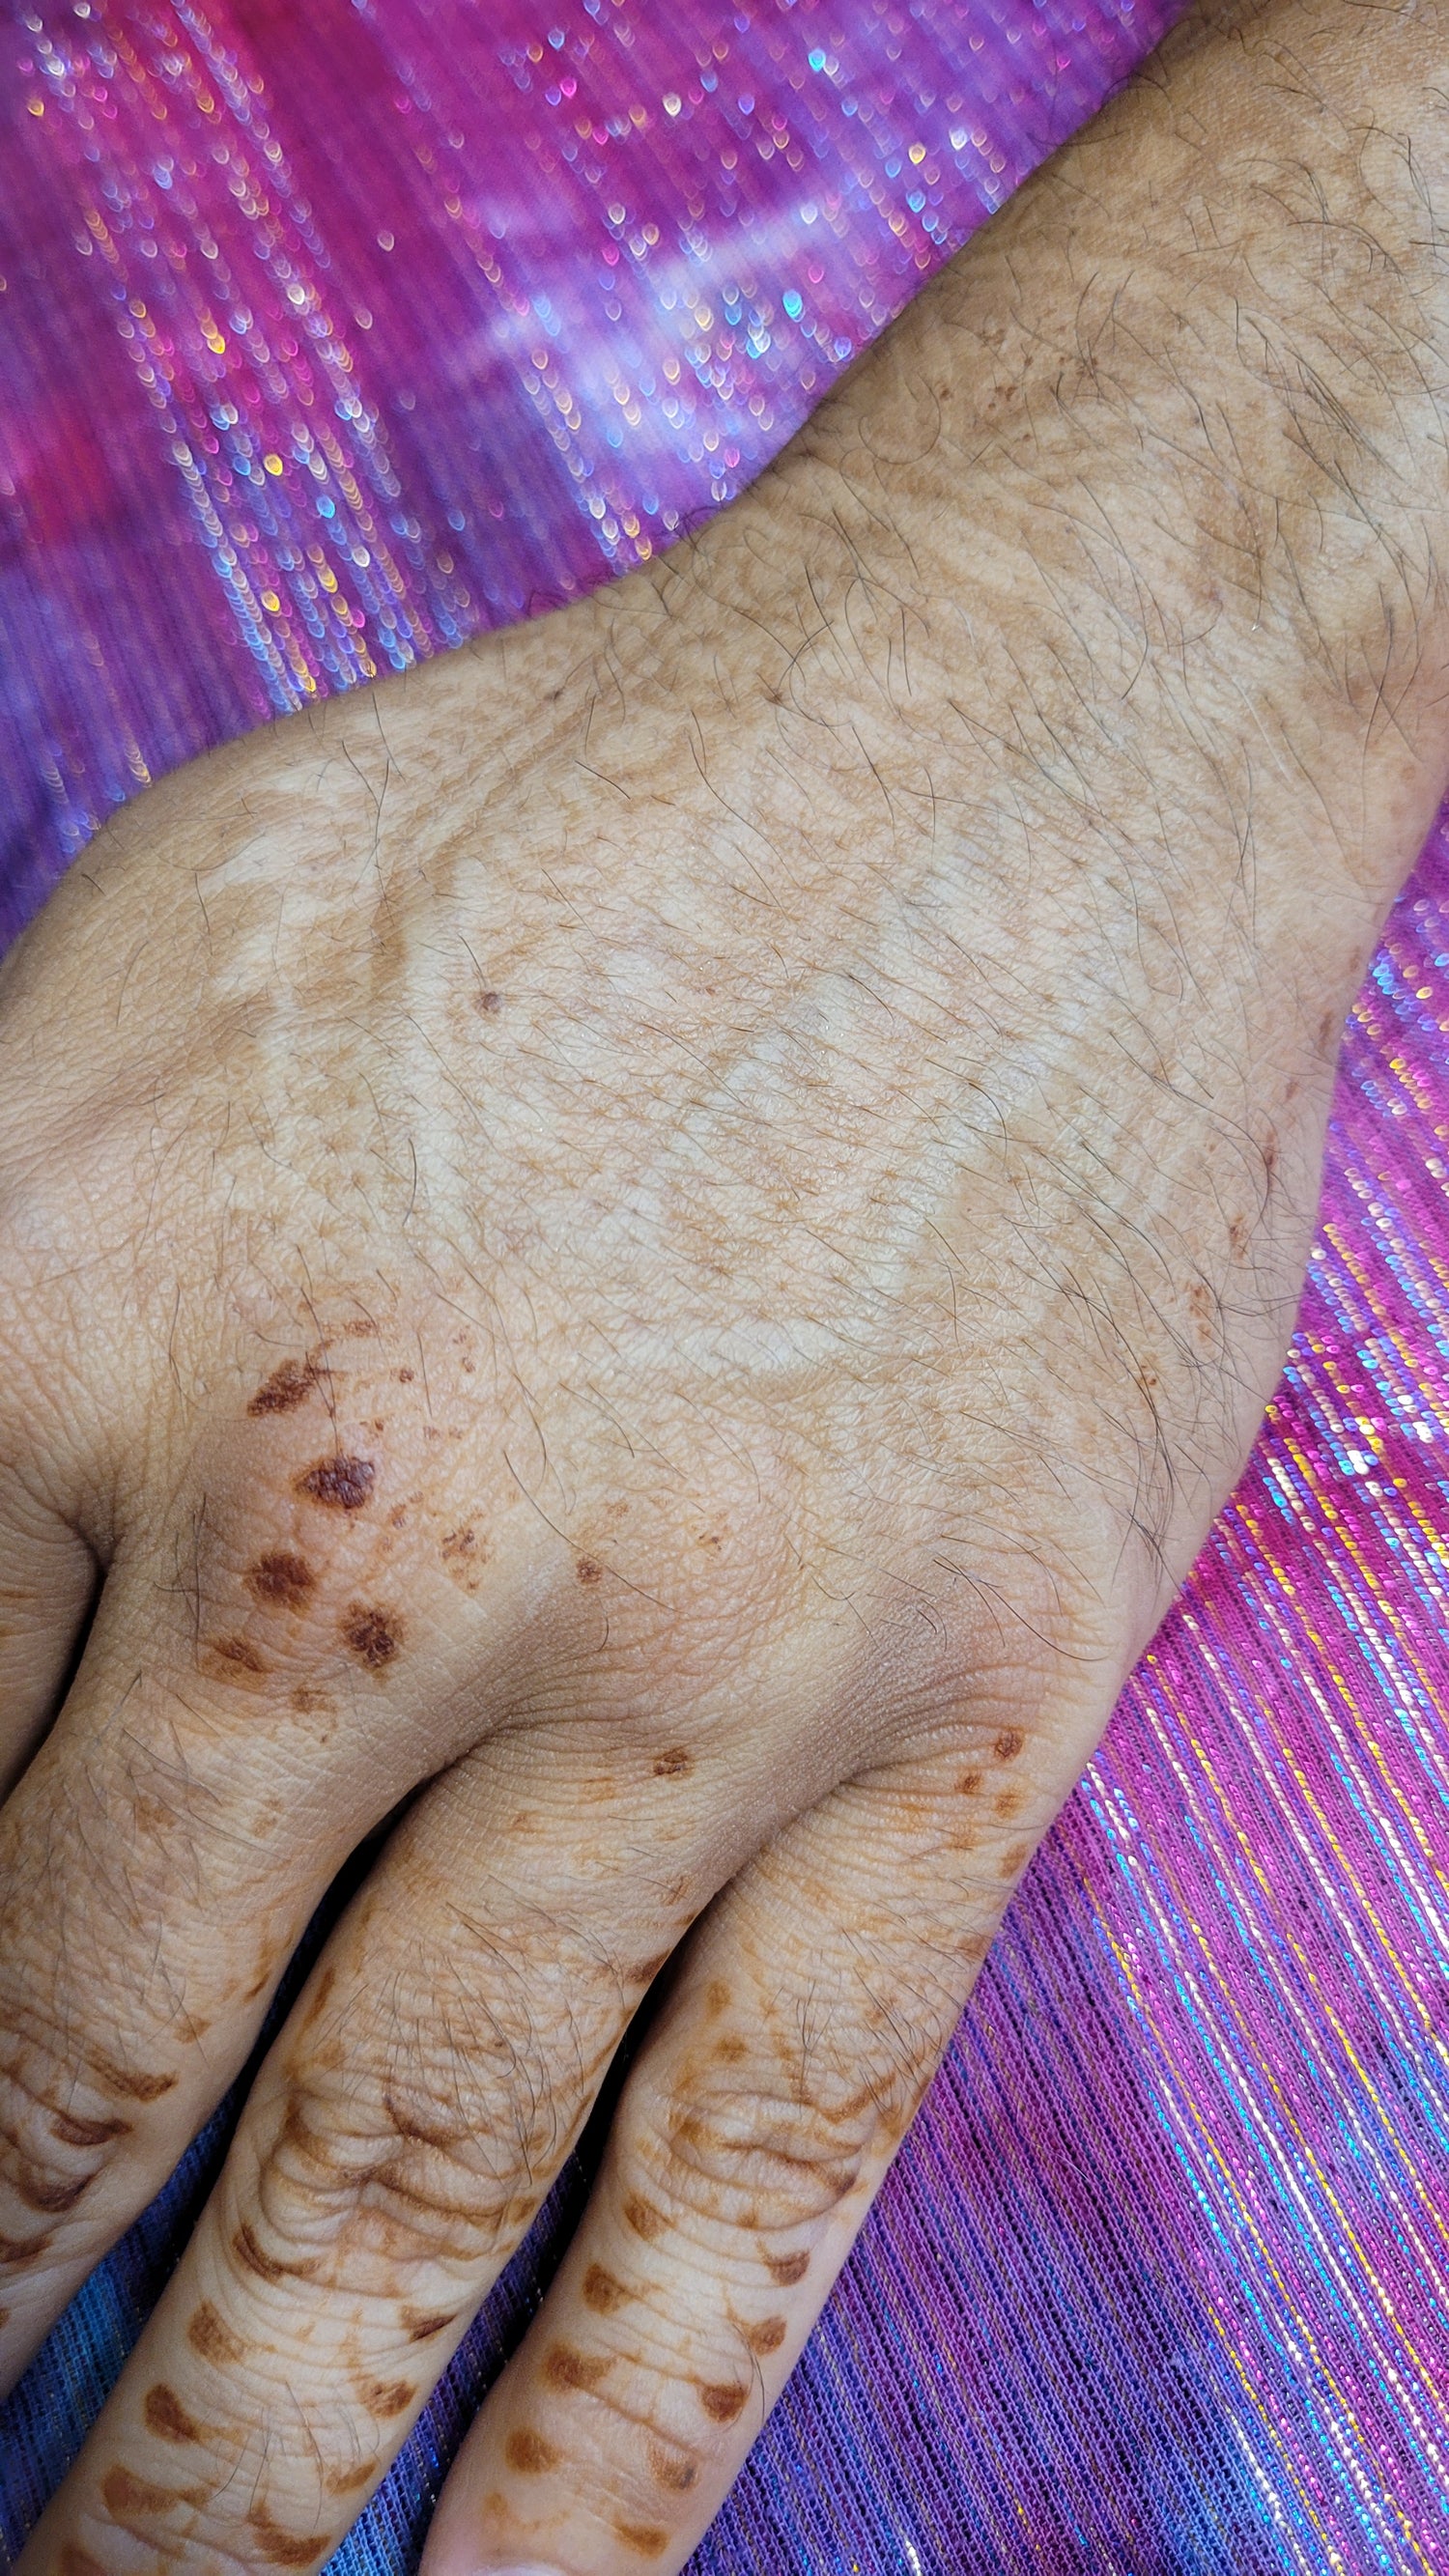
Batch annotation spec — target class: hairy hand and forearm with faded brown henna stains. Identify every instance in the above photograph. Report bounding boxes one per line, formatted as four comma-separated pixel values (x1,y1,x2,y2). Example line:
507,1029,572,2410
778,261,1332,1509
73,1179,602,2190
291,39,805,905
0,0,1449,2576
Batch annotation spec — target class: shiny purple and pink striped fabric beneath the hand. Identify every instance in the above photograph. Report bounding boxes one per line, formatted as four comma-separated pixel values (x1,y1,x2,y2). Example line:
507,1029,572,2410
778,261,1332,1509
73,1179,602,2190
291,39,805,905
0,0,1449,2576
